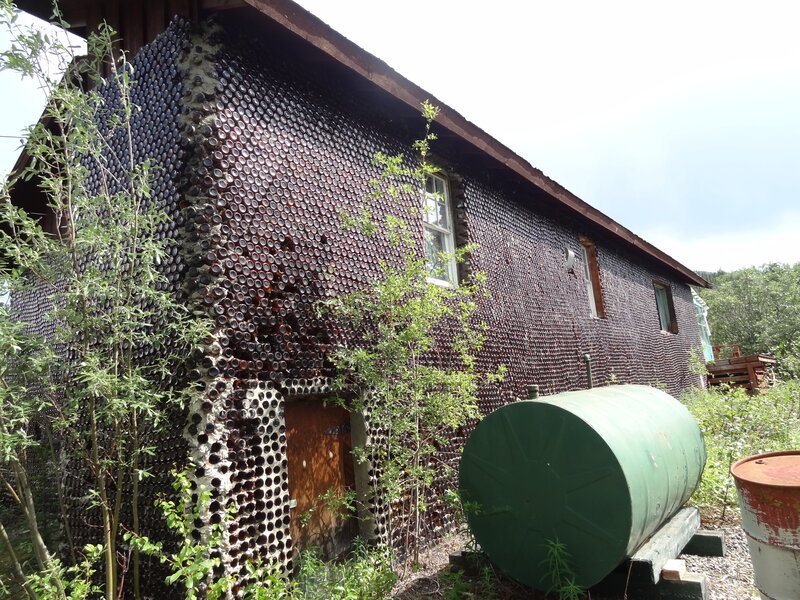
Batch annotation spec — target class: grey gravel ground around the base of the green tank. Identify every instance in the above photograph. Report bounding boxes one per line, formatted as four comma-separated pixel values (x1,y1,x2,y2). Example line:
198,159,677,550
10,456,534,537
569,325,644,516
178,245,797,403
393,510,759,600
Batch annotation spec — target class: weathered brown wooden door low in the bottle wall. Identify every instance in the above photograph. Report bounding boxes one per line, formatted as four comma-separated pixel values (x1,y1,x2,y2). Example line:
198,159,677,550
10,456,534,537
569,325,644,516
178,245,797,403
284,399,358,558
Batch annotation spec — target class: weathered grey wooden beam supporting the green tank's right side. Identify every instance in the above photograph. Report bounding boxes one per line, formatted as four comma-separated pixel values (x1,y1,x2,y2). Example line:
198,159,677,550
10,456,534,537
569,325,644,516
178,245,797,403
630,506,700,584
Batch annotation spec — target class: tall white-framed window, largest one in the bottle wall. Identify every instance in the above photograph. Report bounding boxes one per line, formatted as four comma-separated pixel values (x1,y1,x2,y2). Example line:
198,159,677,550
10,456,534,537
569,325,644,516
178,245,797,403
422,175,458,285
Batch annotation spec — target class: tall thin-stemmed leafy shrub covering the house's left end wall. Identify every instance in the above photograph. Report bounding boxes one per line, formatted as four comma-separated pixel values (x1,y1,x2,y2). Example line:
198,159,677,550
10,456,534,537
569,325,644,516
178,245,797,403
0,5,210,600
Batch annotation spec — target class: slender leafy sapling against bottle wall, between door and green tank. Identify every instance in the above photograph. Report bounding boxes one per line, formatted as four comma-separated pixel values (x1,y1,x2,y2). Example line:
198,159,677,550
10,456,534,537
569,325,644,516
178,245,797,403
322,102,504,560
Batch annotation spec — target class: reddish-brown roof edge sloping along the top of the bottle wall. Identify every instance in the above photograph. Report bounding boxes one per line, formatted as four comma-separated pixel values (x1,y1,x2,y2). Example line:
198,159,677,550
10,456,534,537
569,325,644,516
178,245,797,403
18,0,709,287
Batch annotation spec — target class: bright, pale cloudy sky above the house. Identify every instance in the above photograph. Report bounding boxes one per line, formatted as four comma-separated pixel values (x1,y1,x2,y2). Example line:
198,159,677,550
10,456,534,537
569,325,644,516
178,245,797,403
0,0,800,271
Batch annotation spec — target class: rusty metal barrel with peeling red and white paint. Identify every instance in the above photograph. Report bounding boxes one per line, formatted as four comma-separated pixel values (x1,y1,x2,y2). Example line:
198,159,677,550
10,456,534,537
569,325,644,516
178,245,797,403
731,450,800,600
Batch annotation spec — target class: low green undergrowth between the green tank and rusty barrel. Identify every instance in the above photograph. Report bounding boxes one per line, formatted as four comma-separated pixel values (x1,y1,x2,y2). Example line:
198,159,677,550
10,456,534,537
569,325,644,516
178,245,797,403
681,380,800,507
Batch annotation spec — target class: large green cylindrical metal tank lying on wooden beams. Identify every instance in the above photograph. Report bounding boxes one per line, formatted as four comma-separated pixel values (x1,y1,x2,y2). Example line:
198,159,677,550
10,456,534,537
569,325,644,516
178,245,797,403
459,385,706,589
